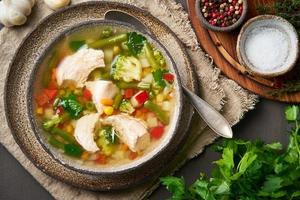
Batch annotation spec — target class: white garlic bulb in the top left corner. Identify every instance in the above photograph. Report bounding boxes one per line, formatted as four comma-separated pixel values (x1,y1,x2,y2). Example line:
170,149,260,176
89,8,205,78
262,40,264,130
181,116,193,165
0,0,35,27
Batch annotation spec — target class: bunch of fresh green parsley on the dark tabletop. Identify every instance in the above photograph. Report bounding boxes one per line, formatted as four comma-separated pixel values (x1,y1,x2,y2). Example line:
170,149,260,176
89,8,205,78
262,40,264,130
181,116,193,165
161,106,300,200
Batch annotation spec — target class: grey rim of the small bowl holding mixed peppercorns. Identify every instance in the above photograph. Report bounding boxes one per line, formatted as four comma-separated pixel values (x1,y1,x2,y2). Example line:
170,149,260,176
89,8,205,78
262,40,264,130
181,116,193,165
195,0,249,32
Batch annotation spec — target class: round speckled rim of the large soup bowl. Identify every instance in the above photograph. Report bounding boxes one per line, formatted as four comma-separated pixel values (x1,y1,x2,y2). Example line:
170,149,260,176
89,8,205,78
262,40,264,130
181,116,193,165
27,19,183,175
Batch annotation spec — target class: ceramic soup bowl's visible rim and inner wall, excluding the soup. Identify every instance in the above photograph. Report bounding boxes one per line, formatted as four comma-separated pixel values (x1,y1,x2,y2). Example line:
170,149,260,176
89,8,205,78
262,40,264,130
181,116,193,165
27,20,183,176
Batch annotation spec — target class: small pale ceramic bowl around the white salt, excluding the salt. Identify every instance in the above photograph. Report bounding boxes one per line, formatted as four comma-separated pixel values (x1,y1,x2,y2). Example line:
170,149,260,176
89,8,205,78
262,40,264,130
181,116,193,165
236,15,299,77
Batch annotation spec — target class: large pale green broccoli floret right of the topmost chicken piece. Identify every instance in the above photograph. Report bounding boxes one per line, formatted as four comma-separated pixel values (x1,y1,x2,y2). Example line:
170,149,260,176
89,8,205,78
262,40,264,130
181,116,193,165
111,56,142,82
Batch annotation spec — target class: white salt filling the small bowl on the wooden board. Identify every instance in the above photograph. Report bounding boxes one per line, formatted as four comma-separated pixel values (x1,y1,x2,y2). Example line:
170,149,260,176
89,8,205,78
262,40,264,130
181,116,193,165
245,27,289,71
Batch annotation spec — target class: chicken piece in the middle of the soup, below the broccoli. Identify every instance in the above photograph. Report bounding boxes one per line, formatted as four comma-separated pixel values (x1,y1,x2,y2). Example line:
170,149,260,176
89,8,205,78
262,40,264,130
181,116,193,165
85,80,118,115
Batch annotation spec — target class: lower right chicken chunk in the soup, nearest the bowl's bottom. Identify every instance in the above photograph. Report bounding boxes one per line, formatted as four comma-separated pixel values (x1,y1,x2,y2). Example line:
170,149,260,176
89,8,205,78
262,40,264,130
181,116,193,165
101,114,150,152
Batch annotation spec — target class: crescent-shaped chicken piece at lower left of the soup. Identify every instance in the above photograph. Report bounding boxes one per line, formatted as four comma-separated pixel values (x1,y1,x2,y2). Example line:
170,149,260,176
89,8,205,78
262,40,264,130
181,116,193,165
74,113,99,152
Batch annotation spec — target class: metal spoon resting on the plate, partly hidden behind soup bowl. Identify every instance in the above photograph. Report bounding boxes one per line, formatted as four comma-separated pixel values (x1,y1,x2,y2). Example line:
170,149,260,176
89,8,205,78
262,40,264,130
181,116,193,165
105,10,232,138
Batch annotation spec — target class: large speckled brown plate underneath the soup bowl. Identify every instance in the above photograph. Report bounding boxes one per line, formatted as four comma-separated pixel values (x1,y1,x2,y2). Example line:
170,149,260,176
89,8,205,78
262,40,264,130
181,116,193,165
5,1,197,190
